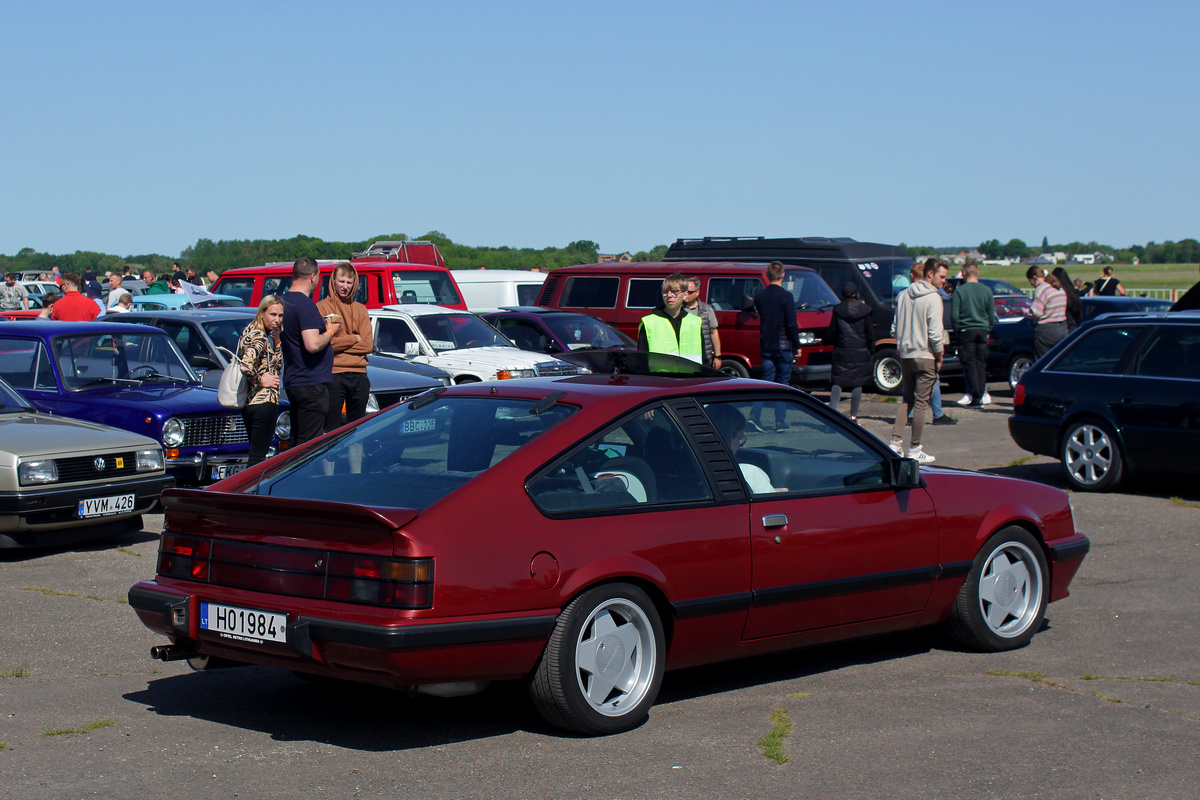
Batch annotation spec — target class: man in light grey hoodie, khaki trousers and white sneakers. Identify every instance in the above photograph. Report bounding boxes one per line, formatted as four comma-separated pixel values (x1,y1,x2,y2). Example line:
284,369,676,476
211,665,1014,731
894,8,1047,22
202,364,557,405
890,258,948,464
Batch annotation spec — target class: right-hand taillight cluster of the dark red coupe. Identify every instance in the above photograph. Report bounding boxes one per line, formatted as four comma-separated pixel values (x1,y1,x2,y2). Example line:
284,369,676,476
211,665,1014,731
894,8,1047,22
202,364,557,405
325,555,433,608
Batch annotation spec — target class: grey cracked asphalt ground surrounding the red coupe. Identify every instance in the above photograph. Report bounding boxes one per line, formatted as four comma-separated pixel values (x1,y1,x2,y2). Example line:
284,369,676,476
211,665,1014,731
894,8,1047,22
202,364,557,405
0,384,1200,800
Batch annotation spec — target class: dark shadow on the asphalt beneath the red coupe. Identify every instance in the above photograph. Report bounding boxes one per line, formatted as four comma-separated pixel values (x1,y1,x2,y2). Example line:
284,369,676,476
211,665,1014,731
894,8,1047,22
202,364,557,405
124,630,949,752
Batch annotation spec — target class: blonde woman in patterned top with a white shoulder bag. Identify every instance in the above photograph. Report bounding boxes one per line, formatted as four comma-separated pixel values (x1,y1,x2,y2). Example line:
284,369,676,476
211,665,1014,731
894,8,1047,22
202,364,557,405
238,295,283,467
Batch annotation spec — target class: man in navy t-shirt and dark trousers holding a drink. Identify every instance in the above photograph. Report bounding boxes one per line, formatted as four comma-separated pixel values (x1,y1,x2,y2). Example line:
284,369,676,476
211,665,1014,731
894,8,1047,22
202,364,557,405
280,255,342,445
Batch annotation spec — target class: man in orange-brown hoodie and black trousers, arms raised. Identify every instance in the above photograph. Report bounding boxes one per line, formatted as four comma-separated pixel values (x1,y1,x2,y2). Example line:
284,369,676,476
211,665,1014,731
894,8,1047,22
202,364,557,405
317,261,374,438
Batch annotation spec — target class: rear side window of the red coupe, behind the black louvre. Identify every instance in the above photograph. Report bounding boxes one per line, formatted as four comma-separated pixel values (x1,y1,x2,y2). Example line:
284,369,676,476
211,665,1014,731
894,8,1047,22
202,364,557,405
529,407,713,515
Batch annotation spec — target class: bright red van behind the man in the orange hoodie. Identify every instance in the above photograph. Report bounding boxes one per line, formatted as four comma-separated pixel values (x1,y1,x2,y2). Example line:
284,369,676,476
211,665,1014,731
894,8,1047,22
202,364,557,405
212,255,467,311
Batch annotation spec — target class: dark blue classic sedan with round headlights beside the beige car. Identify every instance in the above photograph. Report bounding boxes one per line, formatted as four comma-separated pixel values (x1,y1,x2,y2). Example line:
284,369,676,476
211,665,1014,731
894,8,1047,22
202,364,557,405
0,320,287,483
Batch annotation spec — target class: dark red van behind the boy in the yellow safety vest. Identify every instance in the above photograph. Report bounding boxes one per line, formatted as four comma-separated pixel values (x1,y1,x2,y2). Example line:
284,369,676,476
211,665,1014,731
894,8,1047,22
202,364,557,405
538,261,838,383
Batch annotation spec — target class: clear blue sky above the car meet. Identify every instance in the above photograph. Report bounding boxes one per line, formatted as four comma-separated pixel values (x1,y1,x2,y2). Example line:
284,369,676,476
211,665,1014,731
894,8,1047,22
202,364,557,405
0,0,1200,255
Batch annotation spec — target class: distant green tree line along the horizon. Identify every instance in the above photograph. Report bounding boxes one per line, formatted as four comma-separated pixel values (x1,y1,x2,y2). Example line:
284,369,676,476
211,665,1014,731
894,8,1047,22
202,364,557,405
0,230,1200,275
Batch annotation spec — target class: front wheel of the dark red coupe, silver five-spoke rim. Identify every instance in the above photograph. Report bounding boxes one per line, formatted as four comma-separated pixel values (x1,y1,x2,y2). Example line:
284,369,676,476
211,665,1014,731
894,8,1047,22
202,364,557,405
946,525,1050,652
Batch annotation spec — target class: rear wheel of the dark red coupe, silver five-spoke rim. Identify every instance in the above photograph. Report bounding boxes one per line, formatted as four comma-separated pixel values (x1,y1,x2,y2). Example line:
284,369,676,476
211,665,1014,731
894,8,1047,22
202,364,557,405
528,583,666,735
